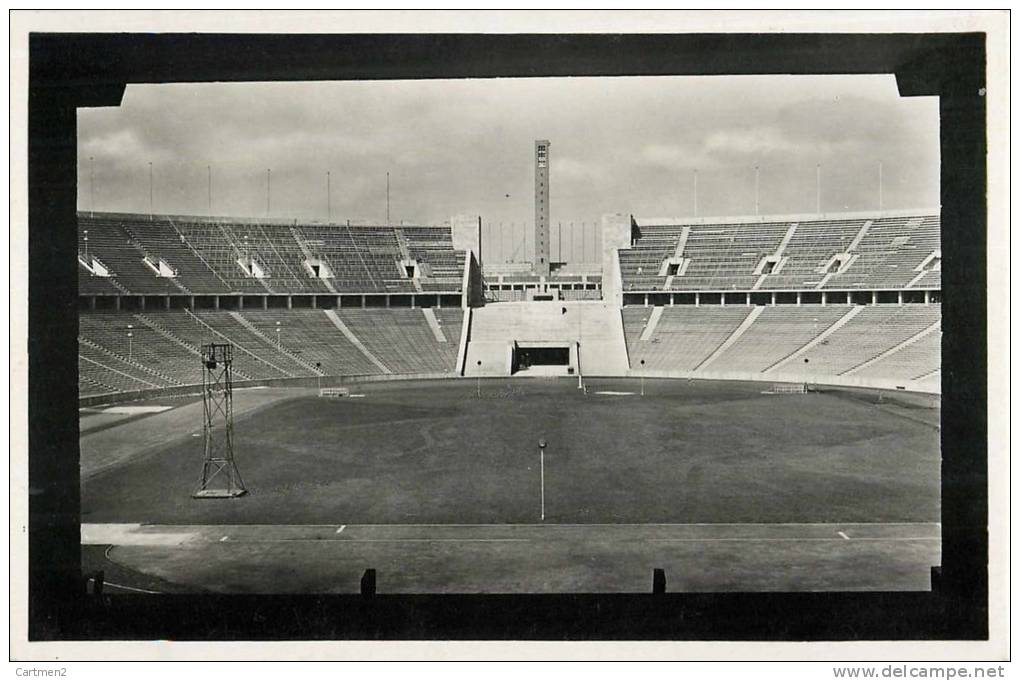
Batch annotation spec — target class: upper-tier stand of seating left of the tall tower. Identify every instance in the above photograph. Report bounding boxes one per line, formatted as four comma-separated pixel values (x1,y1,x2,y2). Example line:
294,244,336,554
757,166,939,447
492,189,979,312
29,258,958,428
79,213,464,295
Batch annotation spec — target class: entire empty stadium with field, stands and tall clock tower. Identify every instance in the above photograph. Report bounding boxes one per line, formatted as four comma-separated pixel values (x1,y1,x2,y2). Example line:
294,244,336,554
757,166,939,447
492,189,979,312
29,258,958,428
78,131,941,593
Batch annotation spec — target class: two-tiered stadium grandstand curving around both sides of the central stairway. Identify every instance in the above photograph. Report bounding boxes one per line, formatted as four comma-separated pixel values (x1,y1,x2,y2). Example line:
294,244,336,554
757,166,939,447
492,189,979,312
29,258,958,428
79,204,941,403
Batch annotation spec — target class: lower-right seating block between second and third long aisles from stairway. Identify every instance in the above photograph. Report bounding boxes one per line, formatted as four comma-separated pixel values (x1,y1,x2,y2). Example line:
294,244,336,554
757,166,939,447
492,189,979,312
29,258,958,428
779,305,941,376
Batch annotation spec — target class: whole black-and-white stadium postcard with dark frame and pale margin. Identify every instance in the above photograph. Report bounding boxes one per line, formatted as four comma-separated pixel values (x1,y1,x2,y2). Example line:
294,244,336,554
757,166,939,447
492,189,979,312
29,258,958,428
11,12,1009,664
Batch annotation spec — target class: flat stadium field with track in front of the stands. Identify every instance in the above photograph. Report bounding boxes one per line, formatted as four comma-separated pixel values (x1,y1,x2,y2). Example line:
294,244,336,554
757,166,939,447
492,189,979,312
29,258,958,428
82,378,939,592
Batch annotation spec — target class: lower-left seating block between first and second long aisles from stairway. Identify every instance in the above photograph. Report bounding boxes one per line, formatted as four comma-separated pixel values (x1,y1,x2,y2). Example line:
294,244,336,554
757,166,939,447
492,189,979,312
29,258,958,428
236,310,381,376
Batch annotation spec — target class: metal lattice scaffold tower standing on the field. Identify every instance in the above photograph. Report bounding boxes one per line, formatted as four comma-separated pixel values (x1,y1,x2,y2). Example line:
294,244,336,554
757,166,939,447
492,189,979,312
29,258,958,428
193,343,248,499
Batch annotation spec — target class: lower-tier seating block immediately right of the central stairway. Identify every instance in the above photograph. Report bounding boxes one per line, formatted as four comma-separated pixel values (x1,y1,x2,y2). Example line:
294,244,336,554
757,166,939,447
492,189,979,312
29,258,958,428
623,306,751,371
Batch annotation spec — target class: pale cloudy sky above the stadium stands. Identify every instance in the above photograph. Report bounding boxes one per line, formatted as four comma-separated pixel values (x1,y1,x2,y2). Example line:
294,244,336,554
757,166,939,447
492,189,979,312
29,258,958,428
79,76,938,230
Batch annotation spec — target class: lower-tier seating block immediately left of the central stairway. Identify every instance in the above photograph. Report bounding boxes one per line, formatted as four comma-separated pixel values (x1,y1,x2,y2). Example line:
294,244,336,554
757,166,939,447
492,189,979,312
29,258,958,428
339,309,460,373
